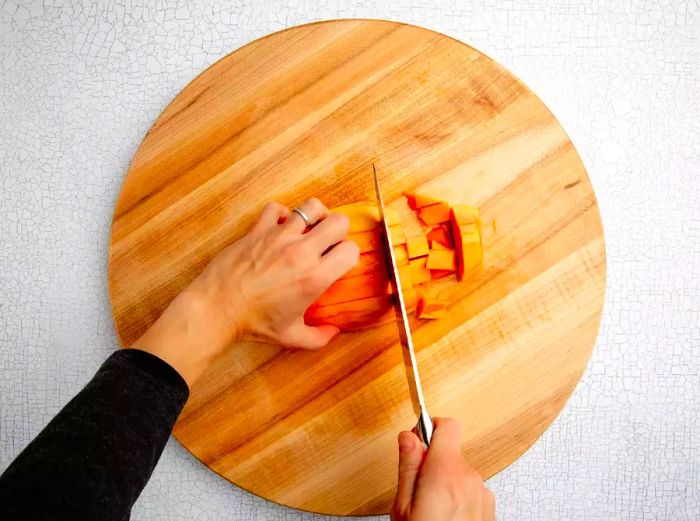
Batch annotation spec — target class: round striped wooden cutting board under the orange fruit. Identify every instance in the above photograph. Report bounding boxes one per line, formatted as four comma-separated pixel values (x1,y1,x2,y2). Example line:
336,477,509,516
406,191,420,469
109,20,605,515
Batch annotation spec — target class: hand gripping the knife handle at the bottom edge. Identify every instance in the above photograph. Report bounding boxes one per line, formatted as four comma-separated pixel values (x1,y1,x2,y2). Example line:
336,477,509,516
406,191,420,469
391,418,496,521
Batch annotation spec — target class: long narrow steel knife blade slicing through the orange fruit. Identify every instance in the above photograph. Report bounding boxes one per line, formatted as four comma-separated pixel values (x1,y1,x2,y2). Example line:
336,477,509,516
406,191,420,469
372,163,433,446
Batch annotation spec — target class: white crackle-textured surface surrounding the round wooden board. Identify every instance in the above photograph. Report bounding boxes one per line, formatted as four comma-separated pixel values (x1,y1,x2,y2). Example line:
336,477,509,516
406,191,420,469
0,0,700,521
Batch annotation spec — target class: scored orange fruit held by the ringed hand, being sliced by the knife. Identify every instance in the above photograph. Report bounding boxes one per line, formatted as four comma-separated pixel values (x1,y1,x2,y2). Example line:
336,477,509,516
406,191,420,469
304,202,417,331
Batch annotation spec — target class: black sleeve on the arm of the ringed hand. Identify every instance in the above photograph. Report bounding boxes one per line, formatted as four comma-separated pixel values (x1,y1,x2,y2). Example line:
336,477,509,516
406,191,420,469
0,349,189,521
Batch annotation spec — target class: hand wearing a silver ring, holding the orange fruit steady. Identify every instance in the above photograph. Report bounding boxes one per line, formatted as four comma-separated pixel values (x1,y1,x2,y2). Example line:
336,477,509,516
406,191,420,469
132,199,359,386
